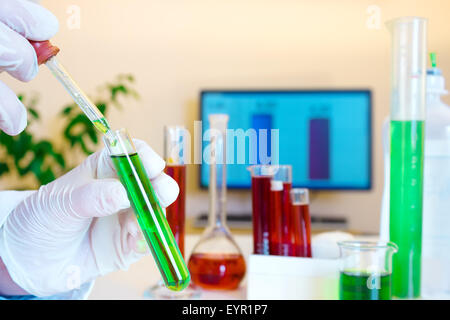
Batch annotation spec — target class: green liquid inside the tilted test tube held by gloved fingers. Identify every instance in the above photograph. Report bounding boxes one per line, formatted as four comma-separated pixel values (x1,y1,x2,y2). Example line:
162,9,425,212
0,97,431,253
111,153,190,291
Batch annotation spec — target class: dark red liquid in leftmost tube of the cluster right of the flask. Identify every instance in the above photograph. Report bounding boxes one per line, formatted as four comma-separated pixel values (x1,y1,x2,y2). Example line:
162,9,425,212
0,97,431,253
252,177,271,254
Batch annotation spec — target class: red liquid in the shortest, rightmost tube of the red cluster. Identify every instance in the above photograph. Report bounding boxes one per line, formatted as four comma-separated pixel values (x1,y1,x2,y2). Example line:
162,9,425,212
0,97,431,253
291,204,311,258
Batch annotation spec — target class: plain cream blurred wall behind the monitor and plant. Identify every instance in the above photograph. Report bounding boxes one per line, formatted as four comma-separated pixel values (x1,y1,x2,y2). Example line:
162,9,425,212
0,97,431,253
0,0,450,232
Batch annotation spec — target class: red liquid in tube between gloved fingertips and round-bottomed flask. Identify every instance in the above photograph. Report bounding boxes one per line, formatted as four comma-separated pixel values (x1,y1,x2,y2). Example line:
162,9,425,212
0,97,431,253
164,165,186,257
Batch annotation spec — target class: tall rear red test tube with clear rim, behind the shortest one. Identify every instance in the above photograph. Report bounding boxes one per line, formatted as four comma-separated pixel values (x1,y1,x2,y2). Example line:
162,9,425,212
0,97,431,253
269,165,295,256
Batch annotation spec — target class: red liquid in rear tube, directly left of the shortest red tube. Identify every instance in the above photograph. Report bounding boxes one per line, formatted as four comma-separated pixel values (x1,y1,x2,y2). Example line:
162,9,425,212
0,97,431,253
281,182,295,256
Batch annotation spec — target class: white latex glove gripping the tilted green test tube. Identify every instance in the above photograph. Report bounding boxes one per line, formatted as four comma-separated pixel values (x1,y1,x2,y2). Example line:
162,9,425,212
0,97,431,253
0,140,179,297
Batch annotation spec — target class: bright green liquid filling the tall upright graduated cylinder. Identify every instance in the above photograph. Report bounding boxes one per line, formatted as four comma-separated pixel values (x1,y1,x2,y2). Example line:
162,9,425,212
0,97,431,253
389,121,425,298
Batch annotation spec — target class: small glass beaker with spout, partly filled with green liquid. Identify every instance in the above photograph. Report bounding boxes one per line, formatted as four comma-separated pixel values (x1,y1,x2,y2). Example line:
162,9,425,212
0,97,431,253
338,241,398,300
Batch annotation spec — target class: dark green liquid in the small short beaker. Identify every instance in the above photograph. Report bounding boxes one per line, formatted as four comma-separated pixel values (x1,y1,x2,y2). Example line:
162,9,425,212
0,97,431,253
339,272,392,300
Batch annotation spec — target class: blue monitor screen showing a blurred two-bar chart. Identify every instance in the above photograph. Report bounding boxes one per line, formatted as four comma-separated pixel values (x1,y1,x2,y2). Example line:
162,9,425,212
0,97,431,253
200,90,371,189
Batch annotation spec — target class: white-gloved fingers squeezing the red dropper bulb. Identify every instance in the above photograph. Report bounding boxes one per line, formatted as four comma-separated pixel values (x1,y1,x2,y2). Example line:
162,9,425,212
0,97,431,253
0,0,58,135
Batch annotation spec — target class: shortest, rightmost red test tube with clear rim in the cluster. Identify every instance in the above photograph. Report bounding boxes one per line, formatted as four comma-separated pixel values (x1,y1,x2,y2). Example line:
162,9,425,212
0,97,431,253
290,188,312,258
